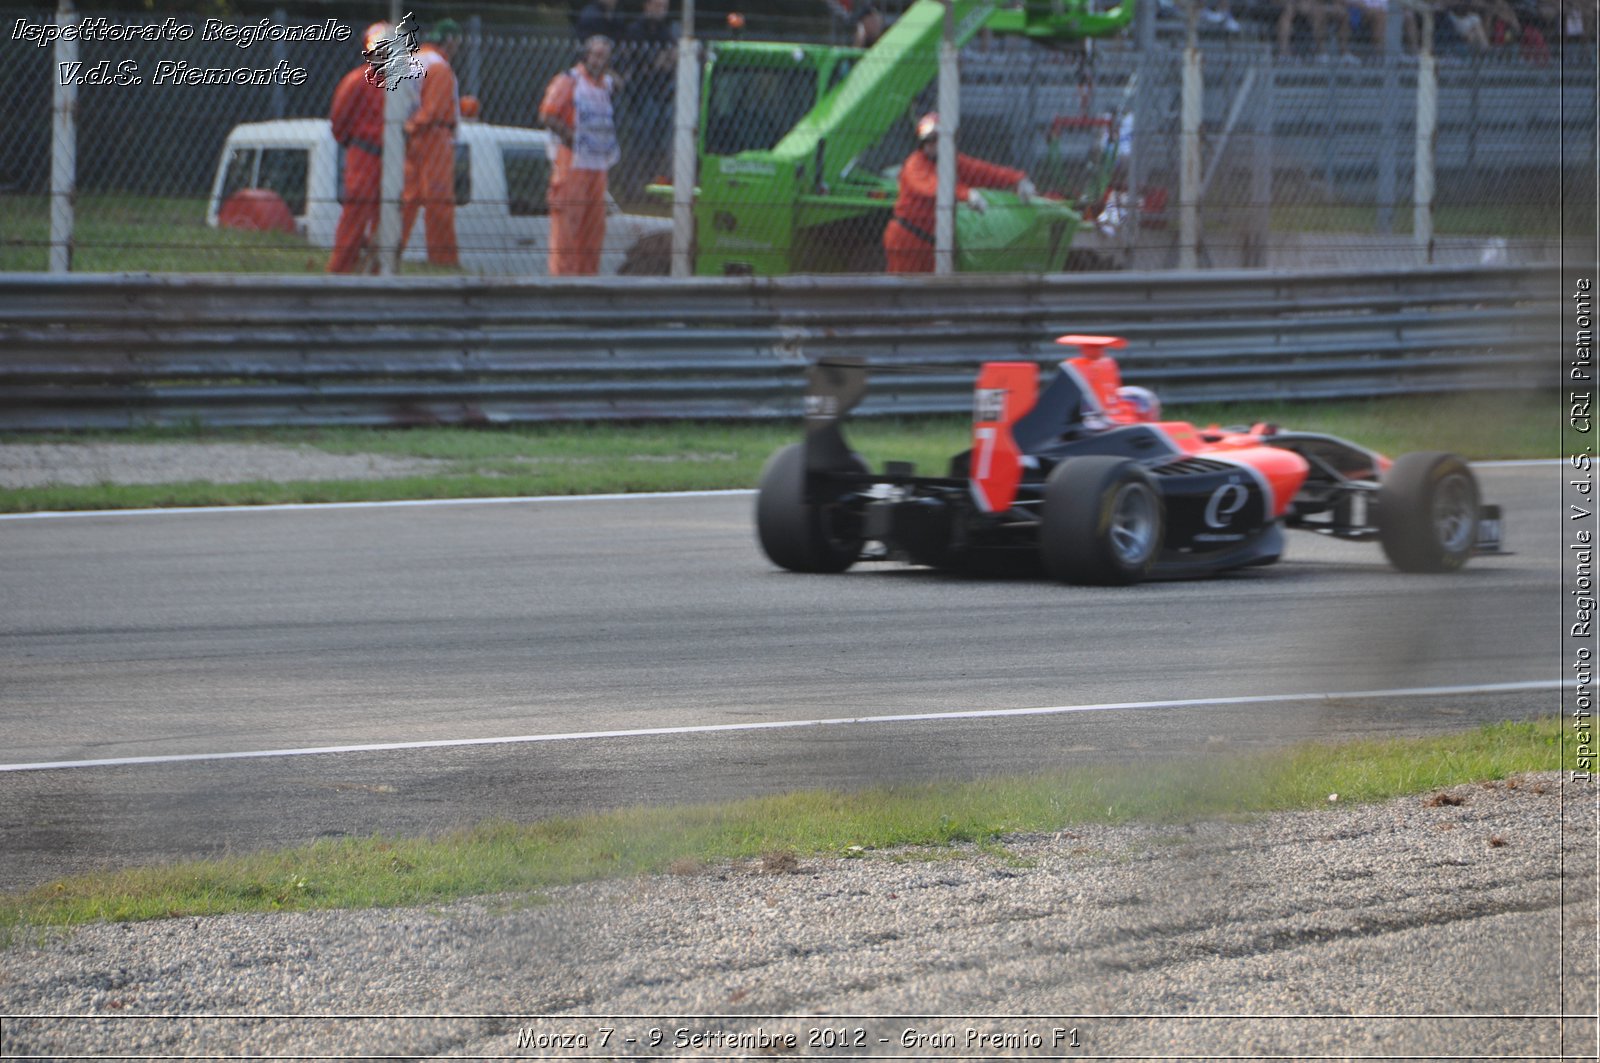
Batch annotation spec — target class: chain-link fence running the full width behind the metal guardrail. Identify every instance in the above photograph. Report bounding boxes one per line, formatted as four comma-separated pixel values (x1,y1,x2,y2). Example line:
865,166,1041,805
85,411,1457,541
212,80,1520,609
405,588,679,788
0,0,1595,275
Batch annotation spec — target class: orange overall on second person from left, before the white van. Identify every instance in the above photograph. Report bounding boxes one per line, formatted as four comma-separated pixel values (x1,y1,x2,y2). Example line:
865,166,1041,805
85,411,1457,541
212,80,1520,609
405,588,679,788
400,45,461,266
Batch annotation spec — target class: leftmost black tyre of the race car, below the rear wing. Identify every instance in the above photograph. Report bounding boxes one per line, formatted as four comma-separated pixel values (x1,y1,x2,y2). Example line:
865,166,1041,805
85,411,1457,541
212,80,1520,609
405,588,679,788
755,443,866,572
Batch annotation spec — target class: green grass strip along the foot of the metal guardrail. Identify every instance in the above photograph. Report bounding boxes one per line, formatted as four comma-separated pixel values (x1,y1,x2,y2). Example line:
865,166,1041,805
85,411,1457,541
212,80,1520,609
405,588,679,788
0,392,1562,512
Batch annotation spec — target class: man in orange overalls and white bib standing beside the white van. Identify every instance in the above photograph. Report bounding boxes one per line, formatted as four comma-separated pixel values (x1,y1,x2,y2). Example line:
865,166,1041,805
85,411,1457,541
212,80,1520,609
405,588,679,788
539,34,621,277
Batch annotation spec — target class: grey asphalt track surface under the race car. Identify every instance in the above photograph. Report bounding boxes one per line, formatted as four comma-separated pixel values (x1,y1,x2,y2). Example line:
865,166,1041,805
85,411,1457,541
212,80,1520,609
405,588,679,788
0,464,1563,889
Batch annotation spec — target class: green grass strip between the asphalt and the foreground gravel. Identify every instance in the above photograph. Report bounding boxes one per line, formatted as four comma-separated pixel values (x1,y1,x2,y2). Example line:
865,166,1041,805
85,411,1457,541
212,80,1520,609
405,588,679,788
0,720,1576,941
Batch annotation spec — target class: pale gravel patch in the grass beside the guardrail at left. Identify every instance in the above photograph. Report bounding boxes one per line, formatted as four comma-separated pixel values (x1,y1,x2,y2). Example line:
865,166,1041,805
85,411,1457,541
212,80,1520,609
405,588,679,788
0,443,450,488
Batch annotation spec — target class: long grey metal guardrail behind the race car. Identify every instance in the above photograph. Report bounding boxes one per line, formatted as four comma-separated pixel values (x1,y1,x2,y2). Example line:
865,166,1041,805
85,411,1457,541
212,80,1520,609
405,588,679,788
0,266,1562,431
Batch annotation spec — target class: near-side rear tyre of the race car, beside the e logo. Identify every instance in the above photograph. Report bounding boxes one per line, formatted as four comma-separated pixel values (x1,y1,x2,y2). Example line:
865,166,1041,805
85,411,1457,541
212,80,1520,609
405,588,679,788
1038,455,1166,584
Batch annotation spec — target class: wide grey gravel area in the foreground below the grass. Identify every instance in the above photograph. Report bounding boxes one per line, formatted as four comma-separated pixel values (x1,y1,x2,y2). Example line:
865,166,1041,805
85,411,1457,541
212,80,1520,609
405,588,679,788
0,773,1597,1058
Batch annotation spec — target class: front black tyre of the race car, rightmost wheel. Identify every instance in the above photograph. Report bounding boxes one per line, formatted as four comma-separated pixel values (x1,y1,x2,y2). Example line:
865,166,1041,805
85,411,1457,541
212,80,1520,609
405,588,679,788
1378,450,1478,572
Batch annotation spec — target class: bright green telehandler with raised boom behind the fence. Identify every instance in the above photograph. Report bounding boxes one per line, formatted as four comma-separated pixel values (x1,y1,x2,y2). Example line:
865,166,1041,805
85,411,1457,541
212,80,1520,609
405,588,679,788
694,0,1134,277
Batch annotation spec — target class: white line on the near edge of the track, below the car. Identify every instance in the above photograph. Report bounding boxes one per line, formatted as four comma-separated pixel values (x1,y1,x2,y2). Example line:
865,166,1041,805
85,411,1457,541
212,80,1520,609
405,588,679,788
0,679,1576,773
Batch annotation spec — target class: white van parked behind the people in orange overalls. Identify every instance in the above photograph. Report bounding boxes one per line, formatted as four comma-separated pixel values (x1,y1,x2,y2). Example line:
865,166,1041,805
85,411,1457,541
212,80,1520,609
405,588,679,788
206,118,672,275
